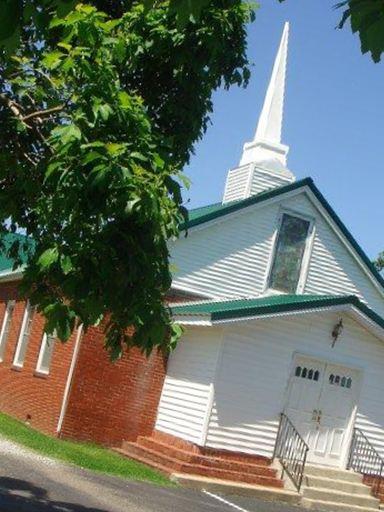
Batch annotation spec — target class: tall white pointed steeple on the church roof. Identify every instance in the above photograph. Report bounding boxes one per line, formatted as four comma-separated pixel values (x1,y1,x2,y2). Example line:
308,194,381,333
223,22,295,202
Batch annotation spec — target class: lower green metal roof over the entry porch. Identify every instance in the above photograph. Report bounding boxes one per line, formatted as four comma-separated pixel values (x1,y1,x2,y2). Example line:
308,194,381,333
171,295,384,329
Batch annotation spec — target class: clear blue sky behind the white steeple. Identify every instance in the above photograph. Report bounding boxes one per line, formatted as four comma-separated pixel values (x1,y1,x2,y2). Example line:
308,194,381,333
184,0,384,258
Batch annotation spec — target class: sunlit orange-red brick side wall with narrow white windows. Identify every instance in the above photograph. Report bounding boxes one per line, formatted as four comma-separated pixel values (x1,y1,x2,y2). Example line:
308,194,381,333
0,283,74,435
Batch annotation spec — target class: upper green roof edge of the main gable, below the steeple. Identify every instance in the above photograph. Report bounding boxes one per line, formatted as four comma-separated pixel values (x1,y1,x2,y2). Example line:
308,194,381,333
184,178,384,294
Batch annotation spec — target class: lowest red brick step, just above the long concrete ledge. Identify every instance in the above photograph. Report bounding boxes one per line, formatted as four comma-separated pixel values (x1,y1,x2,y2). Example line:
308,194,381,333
117,443,283,488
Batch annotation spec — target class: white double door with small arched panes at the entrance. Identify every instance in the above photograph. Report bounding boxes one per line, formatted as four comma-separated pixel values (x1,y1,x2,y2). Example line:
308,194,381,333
285,356,359,467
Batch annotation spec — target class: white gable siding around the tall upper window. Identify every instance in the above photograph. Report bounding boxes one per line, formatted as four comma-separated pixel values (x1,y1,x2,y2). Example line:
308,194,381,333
170,192,384,315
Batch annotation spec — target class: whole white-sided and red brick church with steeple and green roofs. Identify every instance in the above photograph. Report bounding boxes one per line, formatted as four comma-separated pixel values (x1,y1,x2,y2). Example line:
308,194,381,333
0,24,384,512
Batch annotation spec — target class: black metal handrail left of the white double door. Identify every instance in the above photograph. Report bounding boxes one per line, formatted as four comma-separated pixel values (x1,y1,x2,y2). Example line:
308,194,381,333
273,412,309,492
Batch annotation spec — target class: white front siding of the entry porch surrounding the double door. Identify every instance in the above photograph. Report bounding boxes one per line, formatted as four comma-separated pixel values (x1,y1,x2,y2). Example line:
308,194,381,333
206,312,384,457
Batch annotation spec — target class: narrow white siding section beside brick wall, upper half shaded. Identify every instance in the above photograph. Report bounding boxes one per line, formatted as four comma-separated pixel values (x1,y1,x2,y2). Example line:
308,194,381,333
155,328,221,444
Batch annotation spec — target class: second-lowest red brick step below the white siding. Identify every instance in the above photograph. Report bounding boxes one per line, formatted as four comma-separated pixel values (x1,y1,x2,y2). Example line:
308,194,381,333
132,437,276,477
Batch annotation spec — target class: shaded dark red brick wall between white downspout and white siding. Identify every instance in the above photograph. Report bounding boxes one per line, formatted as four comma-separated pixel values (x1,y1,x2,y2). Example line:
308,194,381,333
62,328,166,446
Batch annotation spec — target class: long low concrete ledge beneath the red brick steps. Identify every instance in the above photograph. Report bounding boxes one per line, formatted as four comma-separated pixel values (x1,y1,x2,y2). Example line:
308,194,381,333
171,473,300,505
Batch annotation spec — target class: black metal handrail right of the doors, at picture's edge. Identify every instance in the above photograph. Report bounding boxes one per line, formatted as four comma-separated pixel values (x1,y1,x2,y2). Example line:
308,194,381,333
347,428,384,496
